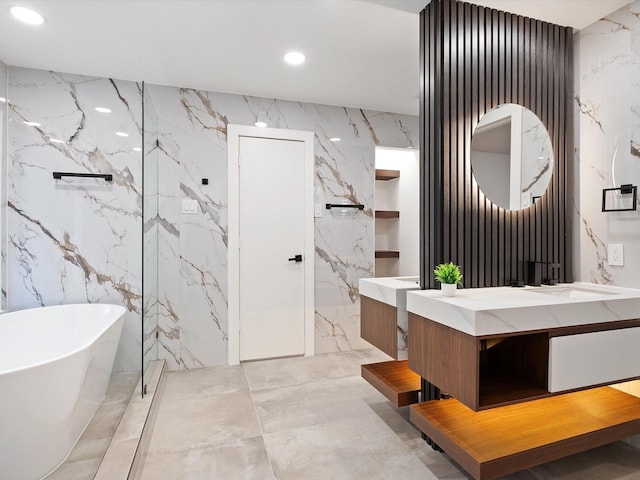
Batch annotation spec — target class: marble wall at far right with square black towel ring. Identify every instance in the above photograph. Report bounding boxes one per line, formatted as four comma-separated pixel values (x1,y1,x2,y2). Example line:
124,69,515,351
574,1,640,288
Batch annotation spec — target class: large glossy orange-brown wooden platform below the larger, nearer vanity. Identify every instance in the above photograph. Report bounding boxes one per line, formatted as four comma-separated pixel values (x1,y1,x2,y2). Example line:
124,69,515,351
410,387,640,480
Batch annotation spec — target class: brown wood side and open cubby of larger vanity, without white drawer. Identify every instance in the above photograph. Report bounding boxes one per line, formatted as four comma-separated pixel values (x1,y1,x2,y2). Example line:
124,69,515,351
409,313,549,410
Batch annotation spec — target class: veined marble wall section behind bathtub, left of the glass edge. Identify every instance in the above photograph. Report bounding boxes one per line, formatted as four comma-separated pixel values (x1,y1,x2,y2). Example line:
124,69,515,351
3,67,142,371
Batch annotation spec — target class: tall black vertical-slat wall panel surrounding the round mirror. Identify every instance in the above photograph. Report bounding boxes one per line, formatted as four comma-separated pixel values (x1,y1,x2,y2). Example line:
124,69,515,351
420,0,573,288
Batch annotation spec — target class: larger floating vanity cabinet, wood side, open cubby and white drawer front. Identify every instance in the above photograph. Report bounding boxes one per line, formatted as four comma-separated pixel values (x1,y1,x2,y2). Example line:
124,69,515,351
409,312,640,411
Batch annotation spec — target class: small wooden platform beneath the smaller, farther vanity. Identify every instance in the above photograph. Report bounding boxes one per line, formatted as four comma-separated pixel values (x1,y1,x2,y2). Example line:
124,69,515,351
361,360,420,407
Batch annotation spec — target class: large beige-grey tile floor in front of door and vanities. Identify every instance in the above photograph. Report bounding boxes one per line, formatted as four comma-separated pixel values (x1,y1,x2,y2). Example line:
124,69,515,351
136,350,640,480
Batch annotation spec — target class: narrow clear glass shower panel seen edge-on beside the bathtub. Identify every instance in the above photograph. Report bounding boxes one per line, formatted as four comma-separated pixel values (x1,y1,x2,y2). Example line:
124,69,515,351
142,82,158,396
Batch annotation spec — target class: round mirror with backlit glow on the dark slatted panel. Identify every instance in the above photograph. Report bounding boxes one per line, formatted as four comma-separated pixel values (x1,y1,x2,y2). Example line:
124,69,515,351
471,103,553,210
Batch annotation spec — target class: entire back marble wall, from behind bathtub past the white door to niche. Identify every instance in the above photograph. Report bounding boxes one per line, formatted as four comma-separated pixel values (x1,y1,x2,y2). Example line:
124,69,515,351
2,67,418,370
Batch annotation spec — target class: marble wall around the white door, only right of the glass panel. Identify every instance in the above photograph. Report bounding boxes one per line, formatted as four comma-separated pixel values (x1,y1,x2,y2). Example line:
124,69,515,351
145,85,418,369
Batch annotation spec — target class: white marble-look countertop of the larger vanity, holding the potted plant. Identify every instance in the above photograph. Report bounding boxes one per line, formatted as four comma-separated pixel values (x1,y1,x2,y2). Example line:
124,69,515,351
407,282,640,336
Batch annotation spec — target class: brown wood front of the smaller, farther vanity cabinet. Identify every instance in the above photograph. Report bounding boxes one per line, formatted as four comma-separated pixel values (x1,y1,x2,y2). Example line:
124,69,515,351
360,295,398,359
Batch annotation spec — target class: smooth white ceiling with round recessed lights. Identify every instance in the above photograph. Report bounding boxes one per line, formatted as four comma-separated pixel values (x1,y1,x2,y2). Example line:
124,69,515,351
0,0,630,114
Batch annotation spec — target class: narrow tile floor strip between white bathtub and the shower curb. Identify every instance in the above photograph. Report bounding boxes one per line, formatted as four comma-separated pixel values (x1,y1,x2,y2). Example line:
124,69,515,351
46,372,140,480
